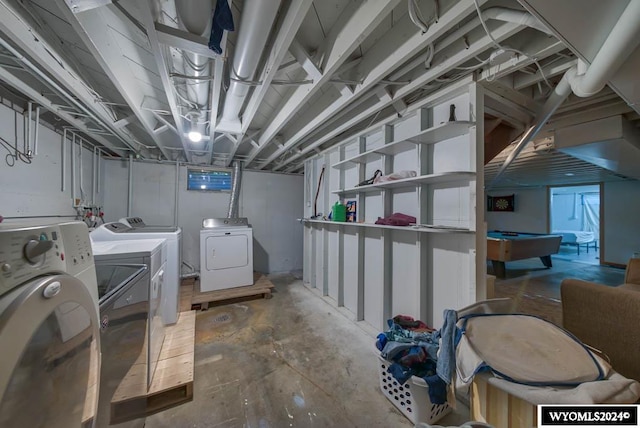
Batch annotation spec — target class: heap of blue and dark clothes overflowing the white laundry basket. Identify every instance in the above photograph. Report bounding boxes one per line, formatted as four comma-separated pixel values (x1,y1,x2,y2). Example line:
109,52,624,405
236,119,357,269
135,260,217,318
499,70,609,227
376,311,460,404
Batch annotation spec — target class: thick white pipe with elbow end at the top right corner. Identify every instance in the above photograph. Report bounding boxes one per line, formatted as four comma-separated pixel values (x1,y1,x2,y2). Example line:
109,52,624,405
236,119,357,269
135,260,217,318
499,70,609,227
567,0,640,97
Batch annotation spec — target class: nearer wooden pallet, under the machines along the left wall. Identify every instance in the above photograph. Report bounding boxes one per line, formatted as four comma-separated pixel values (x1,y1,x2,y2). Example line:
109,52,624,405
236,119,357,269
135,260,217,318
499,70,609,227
111,311,196,424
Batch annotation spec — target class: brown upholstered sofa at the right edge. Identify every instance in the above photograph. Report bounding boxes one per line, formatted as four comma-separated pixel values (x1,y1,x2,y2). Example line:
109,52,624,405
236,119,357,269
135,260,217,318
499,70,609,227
560,259,640,381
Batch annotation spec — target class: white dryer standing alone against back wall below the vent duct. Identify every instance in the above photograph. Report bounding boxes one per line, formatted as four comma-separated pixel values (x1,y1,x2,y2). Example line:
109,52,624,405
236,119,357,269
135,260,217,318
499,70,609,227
200,218,253,292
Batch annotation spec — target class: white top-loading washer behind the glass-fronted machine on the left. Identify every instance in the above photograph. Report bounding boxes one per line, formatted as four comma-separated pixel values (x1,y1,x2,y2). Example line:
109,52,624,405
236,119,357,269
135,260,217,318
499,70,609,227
90,221,182,325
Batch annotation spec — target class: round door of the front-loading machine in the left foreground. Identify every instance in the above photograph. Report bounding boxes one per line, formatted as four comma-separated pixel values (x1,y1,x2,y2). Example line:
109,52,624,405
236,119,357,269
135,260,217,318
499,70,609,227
0,275,100,428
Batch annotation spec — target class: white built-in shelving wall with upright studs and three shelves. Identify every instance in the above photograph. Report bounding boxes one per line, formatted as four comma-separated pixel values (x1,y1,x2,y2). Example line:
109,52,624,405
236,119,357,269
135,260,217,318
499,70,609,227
302,79,486,330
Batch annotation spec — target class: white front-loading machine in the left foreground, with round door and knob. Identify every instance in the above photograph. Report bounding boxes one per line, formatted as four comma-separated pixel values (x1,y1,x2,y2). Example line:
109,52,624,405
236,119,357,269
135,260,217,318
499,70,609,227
0,222,100,428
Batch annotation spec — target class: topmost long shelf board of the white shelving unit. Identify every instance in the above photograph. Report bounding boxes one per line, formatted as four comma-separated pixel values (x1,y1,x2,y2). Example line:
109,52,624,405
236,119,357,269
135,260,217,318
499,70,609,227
331,121,474,169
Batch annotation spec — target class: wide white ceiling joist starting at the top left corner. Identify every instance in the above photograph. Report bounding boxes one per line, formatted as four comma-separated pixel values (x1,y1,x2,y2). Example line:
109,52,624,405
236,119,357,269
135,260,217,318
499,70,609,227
0,0,148,156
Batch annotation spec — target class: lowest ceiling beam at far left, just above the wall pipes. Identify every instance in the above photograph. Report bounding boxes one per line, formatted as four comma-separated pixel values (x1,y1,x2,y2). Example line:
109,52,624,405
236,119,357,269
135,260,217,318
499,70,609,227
0,67,128,157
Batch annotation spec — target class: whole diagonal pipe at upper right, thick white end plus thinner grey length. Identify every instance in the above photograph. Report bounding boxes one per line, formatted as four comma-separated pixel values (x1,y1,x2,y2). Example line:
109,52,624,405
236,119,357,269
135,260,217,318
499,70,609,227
487,1,640,189
